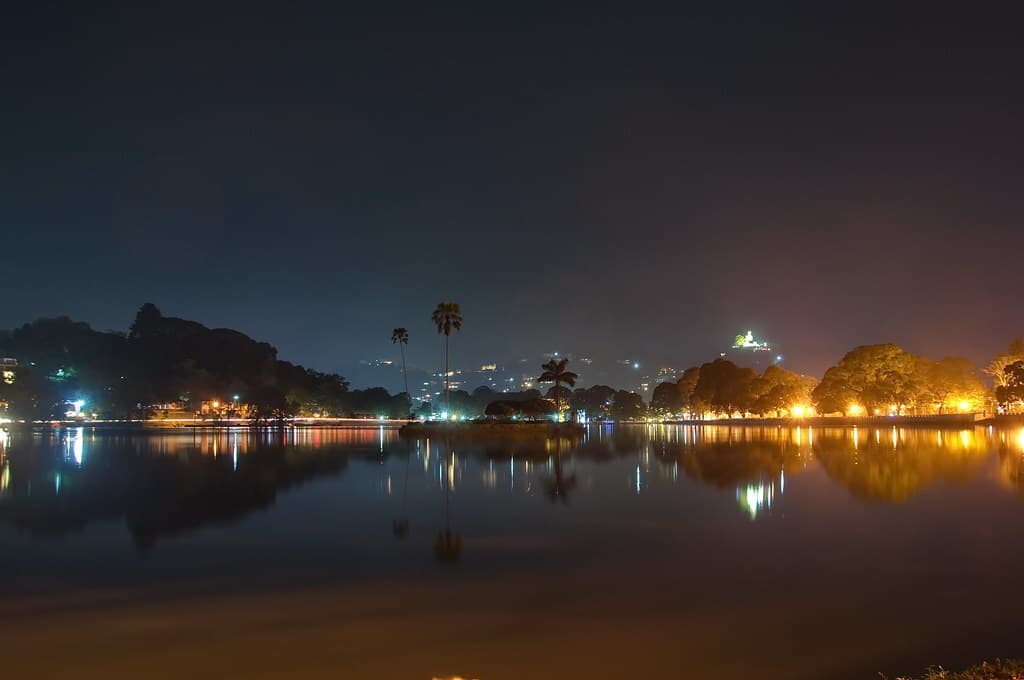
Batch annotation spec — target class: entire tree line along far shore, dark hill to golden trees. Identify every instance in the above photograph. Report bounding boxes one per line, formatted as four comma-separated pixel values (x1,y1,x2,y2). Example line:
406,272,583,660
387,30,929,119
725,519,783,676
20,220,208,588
6,302,1024,420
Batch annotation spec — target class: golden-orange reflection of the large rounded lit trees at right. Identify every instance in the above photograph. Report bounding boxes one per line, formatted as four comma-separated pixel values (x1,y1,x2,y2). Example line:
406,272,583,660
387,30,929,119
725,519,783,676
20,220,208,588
814,430,986,502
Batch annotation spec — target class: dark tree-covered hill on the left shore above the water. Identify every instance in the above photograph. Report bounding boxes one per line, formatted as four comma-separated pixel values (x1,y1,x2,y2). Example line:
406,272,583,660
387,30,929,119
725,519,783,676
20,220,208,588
0,303,351,419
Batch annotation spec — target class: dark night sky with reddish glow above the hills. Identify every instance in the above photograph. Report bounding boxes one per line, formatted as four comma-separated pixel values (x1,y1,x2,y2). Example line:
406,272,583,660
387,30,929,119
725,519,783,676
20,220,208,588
0,0,1024,373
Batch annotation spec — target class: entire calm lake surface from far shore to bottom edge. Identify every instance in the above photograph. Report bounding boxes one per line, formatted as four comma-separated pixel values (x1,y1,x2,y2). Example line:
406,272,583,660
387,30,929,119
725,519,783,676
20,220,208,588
0,426,1024,680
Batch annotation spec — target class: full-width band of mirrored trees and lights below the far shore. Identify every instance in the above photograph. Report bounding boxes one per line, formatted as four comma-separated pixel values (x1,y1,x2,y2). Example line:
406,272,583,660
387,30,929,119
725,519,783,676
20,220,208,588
0,426,1024,563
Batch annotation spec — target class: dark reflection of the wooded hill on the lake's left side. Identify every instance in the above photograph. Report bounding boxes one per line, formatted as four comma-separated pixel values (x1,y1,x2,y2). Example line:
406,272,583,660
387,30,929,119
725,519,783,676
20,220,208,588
0,432,347,549
